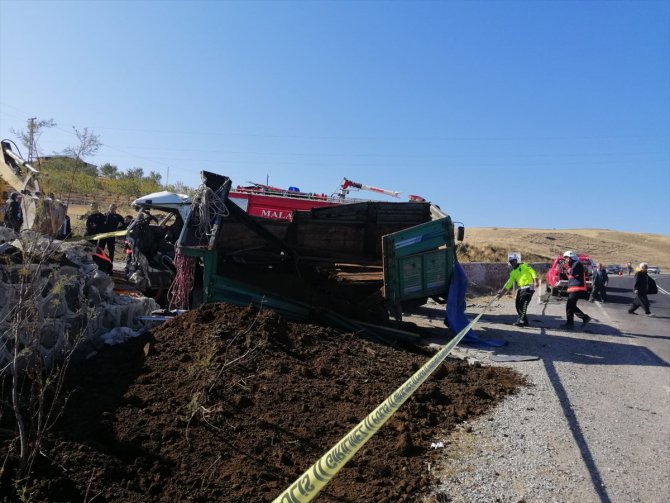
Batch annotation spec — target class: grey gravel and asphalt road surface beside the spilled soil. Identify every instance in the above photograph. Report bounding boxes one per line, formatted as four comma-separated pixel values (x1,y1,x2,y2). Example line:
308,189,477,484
430,276,670,502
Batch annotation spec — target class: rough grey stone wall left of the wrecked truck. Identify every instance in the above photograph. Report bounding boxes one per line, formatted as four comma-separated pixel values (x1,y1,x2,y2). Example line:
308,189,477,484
0,233,158,368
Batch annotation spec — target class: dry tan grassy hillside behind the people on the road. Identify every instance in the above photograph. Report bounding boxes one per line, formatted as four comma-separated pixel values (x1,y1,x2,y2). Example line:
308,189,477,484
459,227,670,270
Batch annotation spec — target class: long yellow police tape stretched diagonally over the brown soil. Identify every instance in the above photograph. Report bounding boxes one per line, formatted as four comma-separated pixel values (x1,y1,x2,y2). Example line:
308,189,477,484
273,312,484,503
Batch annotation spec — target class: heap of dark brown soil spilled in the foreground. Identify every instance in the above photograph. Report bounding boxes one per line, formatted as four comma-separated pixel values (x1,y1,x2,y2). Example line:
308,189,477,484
0,304,524,503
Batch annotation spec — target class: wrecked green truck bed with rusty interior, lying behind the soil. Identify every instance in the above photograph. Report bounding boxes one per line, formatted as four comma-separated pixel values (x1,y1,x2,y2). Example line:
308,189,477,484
172,172,462,326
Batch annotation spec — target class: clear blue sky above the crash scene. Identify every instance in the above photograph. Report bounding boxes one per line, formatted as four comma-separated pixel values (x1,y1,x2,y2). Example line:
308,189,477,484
0,0,670,235
